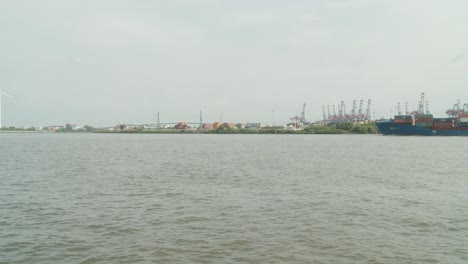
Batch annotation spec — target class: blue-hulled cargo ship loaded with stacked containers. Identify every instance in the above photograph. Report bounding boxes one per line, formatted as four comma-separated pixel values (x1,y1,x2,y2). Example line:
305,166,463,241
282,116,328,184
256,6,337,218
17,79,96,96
375,93,468,136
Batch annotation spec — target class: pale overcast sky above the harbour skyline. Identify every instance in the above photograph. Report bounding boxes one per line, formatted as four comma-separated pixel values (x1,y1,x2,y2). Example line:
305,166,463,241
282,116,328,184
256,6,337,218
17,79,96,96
0,0,468,127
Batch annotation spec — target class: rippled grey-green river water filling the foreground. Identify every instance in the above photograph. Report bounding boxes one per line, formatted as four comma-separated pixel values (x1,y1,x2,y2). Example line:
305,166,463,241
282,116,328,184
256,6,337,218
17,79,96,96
0,134,468,264
